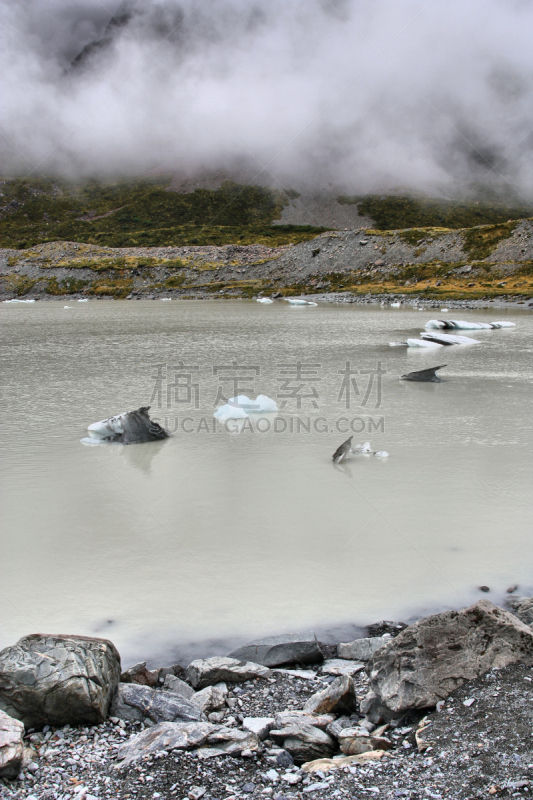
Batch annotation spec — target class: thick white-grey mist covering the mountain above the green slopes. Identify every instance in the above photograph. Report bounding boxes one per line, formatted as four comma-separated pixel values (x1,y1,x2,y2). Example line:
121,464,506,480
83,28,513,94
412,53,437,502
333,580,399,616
0,0,533,200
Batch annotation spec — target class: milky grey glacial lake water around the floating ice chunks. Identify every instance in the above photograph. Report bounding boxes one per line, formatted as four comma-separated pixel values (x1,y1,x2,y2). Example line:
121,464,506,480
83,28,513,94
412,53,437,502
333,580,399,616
0,300,533,666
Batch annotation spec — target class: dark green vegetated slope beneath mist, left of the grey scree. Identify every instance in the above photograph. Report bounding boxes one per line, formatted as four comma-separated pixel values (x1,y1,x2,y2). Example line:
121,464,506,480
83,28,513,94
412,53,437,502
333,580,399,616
0,178,325,249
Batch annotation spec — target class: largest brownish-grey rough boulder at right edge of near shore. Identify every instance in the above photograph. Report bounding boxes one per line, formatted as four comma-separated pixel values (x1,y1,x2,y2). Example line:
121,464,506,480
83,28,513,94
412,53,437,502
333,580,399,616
361,600,533,717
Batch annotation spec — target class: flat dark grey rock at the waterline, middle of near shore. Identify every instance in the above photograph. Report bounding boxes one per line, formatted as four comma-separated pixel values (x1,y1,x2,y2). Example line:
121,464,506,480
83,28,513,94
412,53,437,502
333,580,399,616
229,631,324,667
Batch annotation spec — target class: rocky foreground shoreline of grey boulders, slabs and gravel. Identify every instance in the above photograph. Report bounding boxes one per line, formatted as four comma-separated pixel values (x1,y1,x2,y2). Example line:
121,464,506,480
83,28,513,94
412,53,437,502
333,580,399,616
0,596,533,800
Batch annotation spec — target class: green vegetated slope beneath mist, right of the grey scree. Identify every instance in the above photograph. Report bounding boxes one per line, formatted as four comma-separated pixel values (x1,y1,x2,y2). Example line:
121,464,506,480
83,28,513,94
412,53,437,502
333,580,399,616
337,194,533,231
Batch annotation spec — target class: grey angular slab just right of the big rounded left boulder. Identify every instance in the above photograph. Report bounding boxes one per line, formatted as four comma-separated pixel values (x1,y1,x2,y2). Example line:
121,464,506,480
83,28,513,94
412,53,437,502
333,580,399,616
110,683,203,724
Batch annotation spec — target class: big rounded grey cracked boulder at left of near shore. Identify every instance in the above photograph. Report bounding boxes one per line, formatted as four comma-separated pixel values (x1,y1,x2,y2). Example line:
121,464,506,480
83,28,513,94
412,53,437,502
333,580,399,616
0,633,120,728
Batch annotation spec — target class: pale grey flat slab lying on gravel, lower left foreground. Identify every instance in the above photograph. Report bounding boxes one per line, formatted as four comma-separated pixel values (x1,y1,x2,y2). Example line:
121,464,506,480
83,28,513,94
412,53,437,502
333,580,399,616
117,722,217,769
